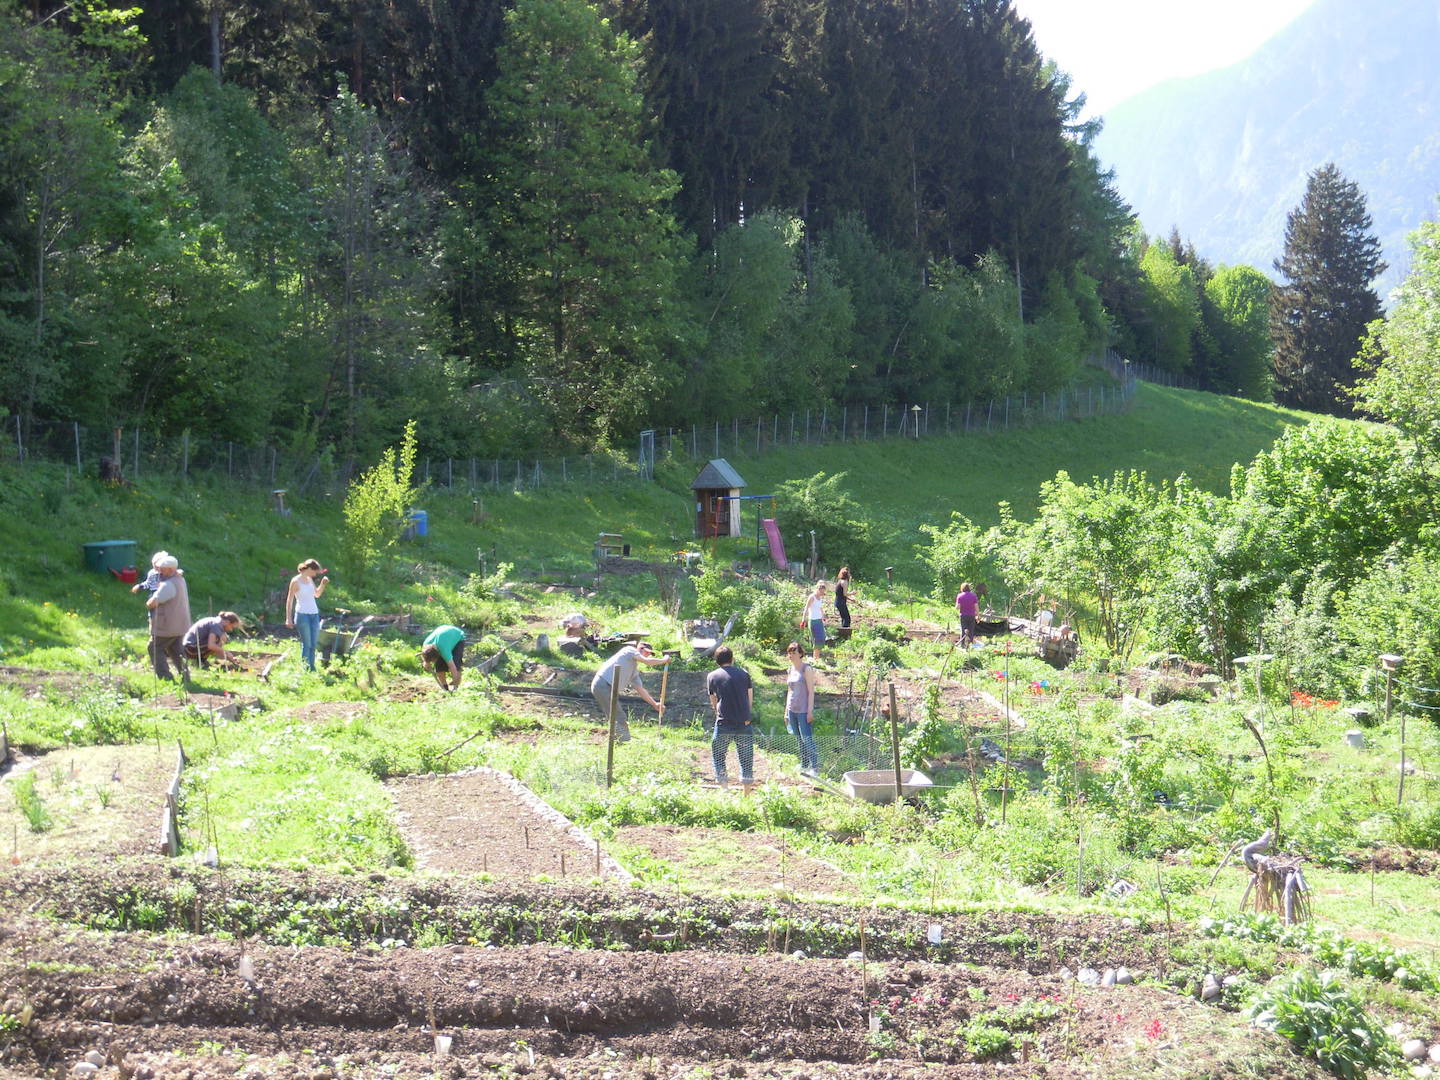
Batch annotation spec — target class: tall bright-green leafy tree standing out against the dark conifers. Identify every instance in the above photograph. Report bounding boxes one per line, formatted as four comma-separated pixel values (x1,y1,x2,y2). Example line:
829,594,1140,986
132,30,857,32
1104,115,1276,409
490,0,678,439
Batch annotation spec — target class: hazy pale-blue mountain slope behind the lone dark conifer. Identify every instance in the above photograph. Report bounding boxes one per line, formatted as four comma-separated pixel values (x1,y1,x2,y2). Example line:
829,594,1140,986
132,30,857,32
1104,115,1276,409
1097,0,1440,295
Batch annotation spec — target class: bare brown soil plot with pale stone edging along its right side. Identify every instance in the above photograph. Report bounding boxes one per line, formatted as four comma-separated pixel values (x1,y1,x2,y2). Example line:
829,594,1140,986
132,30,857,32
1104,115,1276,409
387,769,629,880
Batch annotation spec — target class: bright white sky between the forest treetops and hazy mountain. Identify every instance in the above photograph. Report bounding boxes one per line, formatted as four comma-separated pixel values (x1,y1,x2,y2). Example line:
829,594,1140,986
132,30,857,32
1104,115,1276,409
1015,0,1313,114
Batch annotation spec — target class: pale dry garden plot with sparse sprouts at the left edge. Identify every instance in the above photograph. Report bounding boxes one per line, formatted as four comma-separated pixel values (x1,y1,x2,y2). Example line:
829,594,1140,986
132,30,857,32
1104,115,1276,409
0,744,179,864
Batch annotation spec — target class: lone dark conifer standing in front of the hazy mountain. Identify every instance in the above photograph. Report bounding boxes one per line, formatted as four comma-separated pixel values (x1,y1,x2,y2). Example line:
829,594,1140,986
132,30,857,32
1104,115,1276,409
1270,164,1385,415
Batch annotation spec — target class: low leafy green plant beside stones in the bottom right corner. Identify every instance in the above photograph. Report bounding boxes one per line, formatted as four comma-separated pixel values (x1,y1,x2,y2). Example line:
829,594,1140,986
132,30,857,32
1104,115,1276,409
1250,968,1401,1080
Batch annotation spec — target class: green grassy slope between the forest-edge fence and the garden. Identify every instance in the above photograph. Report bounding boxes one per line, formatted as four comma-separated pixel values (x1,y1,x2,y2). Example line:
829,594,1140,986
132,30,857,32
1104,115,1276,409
0,386,1308,667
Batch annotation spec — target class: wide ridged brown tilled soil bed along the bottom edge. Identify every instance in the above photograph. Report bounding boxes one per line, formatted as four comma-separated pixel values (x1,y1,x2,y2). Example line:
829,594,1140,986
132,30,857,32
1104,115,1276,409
0,917,1316,1080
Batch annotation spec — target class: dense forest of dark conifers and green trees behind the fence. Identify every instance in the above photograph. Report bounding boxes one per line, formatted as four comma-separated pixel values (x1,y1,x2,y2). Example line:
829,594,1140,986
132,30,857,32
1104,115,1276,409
0,0,1313,455
